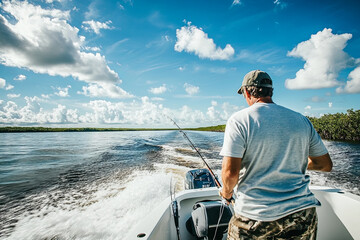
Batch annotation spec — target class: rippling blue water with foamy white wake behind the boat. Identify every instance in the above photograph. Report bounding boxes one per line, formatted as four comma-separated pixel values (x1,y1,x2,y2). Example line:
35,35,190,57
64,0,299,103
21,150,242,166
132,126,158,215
0,131,360,240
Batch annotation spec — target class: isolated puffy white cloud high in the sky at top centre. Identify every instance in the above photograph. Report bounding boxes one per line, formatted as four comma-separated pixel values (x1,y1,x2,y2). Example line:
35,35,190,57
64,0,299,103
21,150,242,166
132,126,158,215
174,22,235,60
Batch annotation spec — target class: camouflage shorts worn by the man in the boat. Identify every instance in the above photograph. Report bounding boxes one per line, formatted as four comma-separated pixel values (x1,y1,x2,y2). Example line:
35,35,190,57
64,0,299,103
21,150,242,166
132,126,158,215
227,208,318,240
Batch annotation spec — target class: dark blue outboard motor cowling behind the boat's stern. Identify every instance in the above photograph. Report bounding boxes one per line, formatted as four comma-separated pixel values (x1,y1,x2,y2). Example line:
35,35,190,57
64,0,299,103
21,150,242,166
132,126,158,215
185,168,215,189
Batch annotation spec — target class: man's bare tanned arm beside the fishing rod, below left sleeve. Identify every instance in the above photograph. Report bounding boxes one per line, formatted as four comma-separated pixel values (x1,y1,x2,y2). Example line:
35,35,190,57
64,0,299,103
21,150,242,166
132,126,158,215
221,157,242,199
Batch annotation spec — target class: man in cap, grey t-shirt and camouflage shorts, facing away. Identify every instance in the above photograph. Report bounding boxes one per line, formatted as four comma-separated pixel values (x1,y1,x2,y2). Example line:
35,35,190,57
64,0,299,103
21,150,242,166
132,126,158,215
220,70,332,240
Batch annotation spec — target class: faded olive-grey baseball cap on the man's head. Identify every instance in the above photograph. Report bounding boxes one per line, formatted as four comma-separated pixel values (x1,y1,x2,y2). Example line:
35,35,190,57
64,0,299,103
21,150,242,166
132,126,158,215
238,70,272,94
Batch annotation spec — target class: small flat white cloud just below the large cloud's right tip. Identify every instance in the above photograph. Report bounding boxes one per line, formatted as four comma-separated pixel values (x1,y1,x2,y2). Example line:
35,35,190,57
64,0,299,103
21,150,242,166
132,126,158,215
77,83,134,98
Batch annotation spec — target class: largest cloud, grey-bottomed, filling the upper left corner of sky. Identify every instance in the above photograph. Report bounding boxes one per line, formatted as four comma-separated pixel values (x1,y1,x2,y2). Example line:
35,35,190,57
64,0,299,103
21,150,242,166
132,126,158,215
0,1,121,90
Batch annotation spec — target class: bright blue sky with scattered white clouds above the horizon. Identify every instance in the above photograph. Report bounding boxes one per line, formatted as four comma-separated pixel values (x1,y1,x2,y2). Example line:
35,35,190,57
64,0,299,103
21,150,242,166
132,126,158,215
0,0,360,128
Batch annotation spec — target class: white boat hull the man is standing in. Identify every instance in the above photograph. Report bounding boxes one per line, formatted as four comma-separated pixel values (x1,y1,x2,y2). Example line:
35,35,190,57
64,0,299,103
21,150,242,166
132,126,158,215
127,175,360,240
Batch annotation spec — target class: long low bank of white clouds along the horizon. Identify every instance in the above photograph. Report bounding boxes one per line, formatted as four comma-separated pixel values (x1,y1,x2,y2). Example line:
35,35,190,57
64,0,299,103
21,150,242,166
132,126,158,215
0,96,239,127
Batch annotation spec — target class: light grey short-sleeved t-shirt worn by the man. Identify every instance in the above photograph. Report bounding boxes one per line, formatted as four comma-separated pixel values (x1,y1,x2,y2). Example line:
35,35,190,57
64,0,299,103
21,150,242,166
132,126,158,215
220,103,328,221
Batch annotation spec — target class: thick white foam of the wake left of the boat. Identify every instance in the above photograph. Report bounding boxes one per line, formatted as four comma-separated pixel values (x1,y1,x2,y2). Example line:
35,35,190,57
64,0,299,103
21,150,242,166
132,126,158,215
7,171,172,240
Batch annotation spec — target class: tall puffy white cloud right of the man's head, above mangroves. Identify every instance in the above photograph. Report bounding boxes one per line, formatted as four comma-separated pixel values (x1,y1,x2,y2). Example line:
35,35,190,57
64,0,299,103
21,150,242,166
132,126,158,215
285,28,355,89
